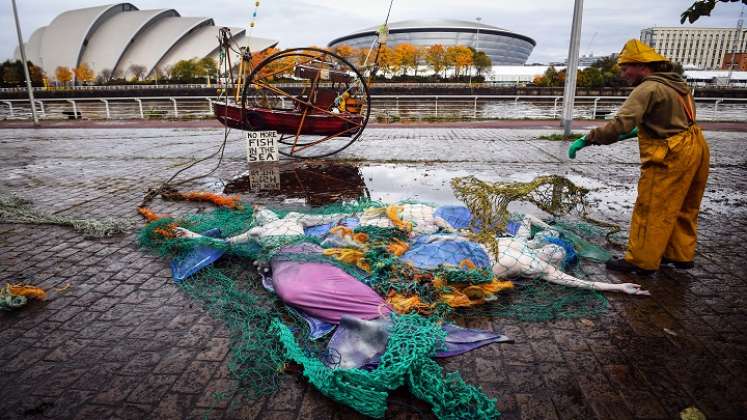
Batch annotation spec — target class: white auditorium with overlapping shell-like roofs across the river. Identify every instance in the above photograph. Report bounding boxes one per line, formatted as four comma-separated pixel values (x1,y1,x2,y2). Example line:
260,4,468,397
15,3,277,78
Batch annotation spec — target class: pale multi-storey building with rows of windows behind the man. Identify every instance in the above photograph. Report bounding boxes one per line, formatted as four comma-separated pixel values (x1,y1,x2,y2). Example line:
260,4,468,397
641,27,747,70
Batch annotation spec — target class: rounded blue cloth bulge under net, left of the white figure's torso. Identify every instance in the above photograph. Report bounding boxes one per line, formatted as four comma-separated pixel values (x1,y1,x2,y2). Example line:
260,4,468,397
400,235,491,270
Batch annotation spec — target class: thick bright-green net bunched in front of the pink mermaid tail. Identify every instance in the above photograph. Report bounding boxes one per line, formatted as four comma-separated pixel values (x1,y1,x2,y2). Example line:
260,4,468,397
273,314,500,419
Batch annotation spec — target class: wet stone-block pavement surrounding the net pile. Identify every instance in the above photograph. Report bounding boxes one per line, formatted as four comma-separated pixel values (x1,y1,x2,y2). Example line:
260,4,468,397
0,127,747,419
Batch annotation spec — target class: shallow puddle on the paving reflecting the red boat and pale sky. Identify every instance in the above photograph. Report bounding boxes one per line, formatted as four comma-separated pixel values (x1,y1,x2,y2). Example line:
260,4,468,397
219,161,747,223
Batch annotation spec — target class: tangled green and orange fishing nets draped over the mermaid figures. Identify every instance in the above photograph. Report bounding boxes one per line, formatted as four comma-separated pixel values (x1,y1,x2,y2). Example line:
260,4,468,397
139,177,607,418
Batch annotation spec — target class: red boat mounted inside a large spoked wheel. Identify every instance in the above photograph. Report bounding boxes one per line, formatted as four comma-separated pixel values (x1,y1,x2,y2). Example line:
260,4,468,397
213,48,371,158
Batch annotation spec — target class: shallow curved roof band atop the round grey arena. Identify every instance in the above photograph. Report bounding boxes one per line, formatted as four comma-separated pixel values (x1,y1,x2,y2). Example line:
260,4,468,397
327,19,537,46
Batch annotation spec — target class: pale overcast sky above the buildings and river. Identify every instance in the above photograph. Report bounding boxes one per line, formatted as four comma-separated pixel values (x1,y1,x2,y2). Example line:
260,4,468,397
0,0,741,63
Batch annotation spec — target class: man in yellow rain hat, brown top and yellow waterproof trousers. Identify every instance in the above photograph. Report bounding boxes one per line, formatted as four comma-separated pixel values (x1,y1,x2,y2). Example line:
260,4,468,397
568,39,710,274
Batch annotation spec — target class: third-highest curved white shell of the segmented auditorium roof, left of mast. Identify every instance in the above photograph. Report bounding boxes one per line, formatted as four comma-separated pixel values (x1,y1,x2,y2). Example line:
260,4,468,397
114,17,214,75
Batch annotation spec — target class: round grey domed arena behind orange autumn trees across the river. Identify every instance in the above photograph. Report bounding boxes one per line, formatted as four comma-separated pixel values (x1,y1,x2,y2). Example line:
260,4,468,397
328,20,537,65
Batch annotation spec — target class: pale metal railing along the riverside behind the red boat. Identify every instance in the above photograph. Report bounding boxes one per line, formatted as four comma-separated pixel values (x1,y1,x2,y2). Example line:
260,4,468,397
0,95,747,122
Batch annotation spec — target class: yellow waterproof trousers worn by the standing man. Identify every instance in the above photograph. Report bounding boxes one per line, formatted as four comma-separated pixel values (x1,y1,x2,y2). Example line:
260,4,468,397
625,124,710,270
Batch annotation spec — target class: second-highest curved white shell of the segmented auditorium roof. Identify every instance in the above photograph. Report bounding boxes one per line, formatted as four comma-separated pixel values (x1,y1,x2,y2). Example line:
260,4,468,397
80,9,179,73
